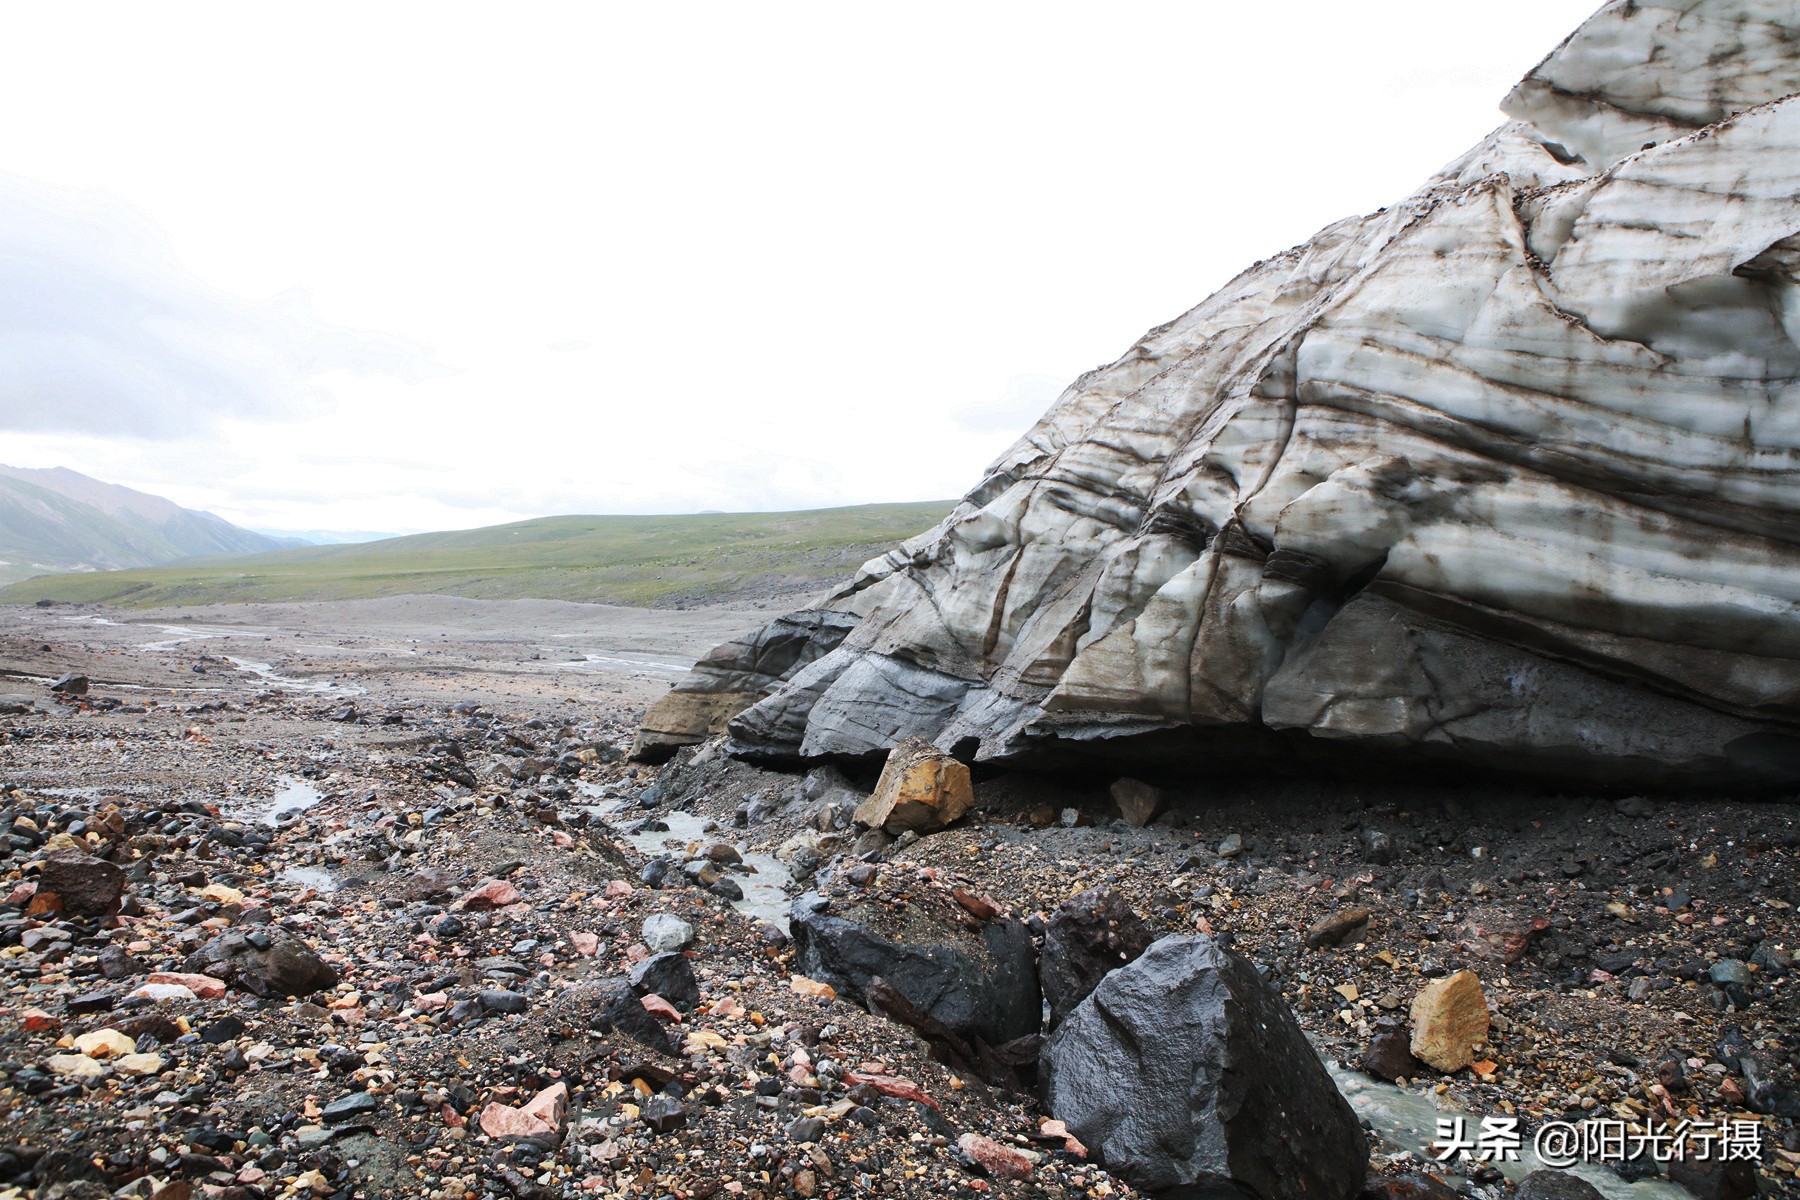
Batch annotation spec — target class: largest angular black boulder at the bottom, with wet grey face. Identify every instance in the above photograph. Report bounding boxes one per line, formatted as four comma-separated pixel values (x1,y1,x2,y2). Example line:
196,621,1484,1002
1044,937,1368,1200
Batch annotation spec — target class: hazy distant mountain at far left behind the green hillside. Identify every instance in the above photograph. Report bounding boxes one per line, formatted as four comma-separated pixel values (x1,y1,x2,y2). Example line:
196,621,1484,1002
0,466,295,581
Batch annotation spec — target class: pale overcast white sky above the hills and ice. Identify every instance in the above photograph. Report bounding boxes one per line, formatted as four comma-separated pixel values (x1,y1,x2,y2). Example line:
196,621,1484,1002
0,0,1597,533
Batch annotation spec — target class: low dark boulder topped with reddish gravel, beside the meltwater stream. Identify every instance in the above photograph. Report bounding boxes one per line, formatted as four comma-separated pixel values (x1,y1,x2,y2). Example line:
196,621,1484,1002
788,892,1044,1045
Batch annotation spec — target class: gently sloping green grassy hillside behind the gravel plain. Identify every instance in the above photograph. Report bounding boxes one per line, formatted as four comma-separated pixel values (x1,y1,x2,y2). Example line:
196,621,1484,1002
0,500,952,608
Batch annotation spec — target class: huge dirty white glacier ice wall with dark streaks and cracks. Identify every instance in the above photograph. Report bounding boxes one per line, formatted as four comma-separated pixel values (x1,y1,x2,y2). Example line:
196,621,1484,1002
648,0,1800,784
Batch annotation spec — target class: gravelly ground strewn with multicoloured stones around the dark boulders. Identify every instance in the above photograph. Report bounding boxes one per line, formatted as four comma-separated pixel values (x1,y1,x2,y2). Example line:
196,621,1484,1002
0,601,1800,1200
